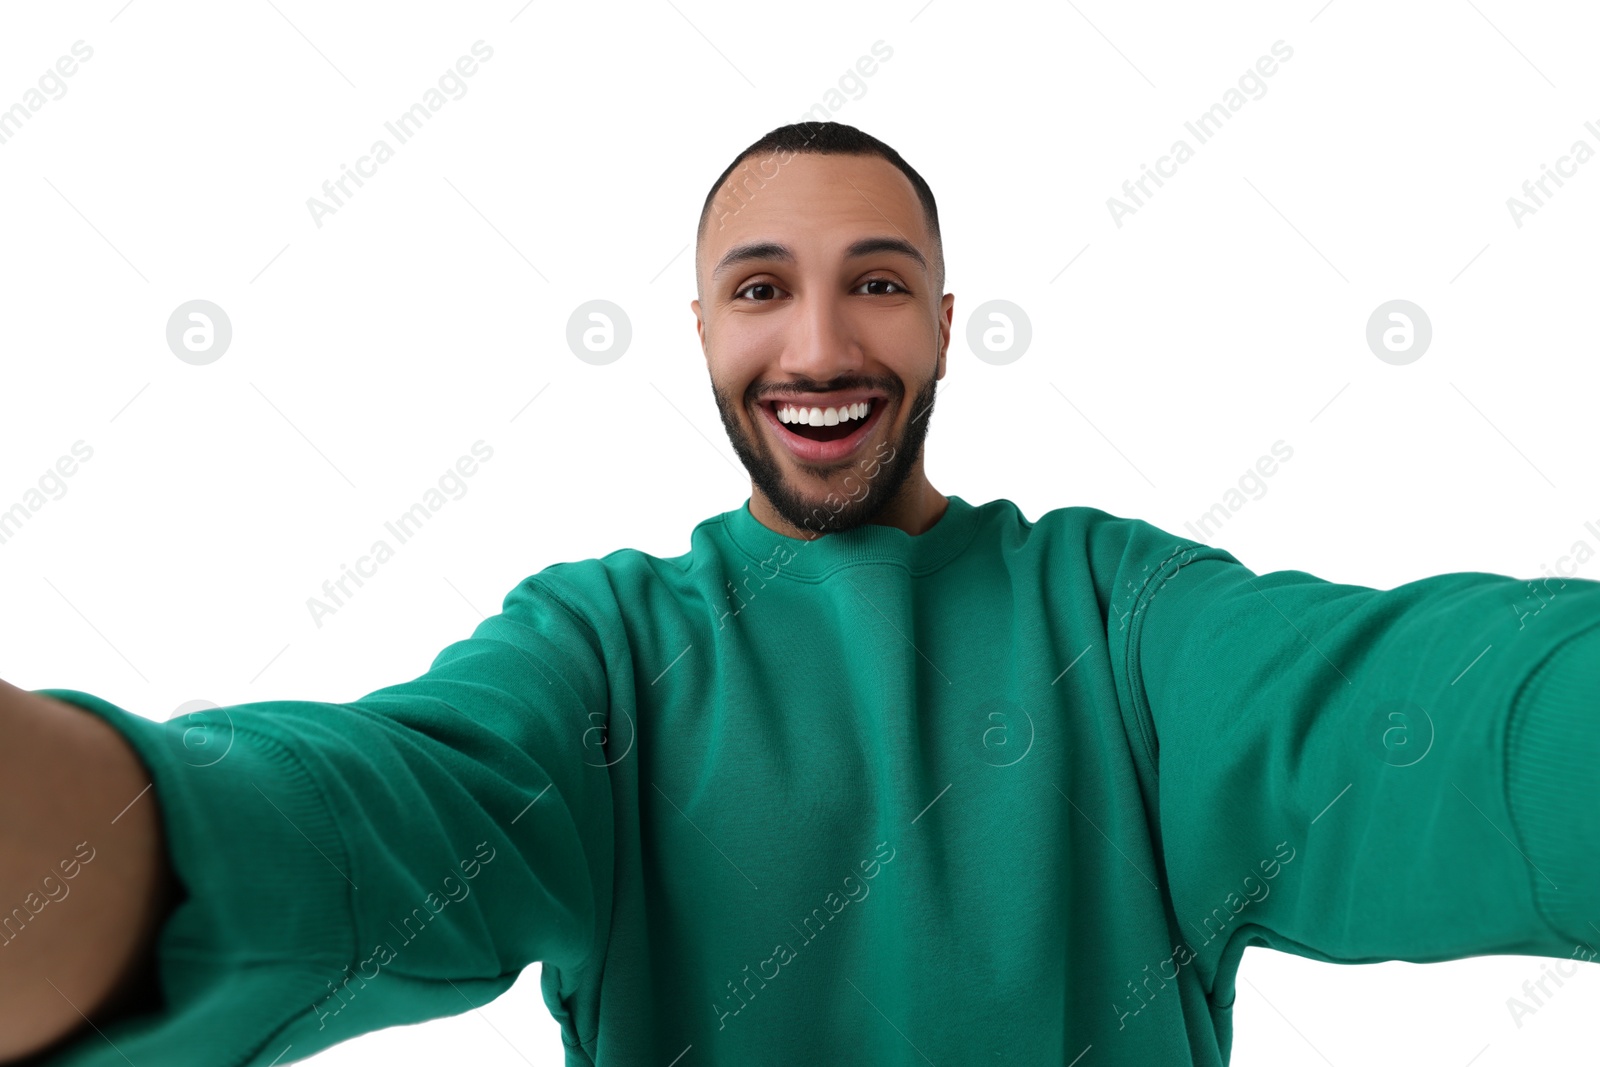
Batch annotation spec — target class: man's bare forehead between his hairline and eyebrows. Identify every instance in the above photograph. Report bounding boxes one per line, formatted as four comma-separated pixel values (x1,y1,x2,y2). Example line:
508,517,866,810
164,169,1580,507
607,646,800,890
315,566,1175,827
698,154,930,280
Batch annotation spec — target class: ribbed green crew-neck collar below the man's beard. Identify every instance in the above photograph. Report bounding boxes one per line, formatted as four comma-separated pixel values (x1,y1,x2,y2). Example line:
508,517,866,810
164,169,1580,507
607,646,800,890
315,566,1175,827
718,494,978,579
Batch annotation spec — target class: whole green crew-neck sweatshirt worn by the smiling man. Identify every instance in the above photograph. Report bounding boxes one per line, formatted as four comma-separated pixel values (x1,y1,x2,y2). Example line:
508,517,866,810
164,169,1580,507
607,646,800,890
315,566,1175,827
25,496,1600,1067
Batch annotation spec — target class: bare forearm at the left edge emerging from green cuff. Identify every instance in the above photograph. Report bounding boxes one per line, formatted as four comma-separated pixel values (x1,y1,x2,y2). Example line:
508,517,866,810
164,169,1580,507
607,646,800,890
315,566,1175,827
0,681,174,1062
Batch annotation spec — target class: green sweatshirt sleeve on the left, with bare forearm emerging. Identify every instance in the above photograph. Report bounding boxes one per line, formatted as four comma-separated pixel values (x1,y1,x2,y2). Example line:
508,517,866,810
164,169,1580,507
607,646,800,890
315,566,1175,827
38,577,613,1067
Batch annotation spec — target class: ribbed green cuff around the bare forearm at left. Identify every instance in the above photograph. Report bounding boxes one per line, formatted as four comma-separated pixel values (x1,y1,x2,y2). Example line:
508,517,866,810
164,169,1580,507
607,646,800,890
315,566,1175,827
37,689,358,1067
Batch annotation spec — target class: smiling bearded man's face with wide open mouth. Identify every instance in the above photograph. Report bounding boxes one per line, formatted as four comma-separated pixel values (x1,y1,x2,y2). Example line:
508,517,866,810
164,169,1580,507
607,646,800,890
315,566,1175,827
690,154,954,537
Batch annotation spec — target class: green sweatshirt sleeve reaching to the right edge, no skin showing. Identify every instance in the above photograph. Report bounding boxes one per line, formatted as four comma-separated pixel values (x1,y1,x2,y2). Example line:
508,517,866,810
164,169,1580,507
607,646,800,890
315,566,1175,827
1126,539,1600,1008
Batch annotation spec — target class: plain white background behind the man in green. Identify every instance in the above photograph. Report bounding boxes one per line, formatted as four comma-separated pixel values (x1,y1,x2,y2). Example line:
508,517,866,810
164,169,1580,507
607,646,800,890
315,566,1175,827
0,0,1600,1067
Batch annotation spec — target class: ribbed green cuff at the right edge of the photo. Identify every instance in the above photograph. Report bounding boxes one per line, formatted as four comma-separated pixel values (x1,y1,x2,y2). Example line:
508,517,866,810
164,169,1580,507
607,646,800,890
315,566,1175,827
1506,629,1600,944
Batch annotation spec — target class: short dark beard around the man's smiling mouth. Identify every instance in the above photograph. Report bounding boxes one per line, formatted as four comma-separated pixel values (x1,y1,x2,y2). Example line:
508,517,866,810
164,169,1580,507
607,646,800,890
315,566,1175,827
710,363,939,533
